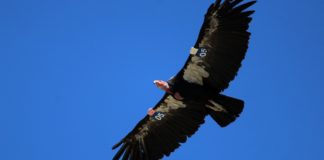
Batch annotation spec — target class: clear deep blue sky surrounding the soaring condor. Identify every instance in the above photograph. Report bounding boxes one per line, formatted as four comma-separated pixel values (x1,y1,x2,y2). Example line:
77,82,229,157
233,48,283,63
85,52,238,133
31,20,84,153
0,0,324,160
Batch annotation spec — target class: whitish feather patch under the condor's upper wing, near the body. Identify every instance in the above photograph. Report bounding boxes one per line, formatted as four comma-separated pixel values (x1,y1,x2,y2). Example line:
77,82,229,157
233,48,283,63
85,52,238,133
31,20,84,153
183,56,209,85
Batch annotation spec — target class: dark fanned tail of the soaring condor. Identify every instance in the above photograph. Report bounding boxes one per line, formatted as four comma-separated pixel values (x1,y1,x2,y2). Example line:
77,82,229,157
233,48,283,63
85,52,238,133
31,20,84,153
205,94,244,127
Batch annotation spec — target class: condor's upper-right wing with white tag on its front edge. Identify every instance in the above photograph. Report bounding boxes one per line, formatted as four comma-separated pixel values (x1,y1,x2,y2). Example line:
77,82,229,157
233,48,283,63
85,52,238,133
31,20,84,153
176,0,256,92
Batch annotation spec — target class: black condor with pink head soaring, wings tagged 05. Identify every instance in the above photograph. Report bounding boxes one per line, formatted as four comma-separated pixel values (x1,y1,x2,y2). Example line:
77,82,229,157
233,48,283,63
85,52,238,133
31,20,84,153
113,0,256,160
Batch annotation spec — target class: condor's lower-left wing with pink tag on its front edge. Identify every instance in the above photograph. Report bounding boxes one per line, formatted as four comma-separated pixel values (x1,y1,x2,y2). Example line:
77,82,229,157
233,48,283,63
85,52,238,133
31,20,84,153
113,94,206,160
